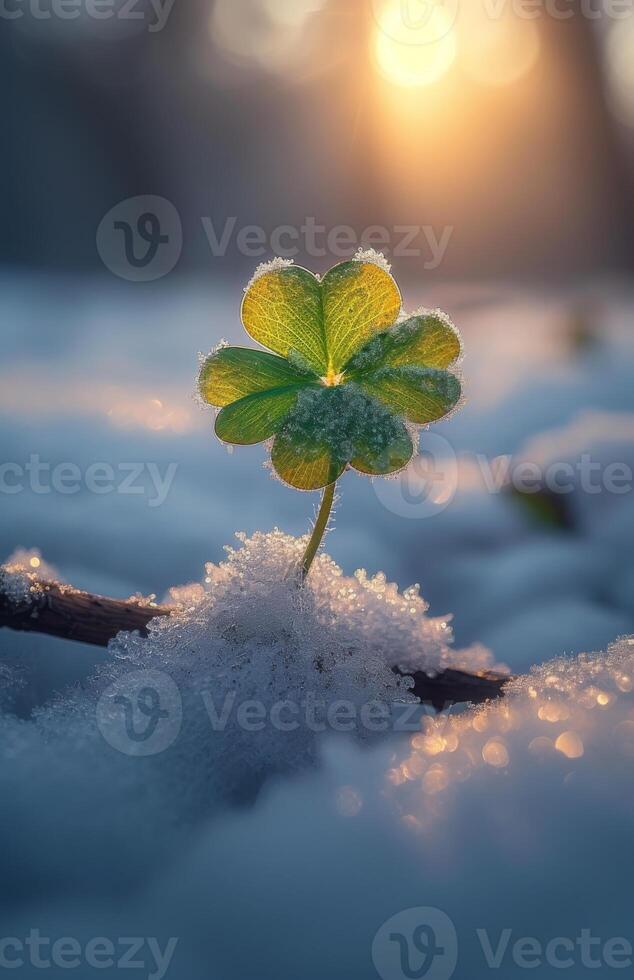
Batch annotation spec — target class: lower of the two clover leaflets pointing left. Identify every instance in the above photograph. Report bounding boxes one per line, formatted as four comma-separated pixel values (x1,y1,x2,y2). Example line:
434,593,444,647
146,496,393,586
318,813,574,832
216,385,302,446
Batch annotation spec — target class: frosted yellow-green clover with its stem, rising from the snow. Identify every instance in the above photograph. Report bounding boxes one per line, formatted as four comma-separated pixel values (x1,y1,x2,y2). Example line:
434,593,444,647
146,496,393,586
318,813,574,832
199,250,461,580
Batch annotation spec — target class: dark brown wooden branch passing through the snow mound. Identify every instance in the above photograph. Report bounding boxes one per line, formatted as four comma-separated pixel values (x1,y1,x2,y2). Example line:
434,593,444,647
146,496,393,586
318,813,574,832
0,573,510,708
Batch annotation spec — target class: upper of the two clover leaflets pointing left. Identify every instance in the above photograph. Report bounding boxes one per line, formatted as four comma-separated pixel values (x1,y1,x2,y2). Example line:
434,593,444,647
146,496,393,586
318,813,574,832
198,347,308,408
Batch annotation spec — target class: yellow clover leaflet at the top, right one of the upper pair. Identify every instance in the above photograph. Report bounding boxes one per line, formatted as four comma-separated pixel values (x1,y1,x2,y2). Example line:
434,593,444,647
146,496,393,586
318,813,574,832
321,260,401,374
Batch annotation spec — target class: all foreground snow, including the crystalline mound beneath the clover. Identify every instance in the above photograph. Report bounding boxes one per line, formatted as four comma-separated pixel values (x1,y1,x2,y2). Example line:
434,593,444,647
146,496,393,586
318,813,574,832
0,533,634,980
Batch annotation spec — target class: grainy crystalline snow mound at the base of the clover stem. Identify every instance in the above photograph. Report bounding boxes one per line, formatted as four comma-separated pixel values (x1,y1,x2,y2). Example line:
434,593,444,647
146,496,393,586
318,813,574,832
102,530,470,796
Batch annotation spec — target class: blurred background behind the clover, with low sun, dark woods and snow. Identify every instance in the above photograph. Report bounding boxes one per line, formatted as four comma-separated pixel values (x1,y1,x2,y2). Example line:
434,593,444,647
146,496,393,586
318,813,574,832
0,0,634,702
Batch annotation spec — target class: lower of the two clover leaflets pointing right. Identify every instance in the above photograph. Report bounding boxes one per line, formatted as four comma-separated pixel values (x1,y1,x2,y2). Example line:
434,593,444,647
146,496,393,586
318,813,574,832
358,367,461,425
